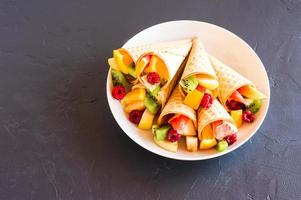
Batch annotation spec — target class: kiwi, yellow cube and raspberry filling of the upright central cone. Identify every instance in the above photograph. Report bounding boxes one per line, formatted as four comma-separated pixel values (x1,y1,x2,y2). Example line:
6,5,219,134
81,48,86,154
180,75,218,110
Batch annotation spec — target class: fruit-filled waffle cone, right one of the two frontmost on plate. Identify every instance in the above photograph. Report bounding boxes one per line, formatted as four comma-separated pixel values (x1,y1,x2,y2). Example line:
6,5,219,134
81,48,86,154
198,100,238,152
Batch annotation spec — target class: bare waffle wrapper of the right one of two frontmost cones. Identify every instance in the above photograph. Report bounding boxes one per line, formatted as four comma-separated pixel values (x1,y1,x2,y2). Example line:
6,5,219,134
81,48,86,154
198,100,234,138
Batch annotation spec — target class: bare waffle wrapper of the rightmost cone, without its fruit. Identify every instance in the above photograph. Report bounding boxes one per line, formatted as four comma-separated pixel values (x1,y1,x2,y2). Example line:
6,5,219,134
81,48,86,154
209,56,254,106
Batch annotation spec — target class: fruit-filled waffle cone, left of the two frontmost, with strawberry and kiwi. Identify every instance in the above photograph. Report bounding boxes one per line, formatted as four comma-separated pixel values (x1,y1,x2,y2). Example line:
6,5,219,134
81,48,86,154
152,87,198,152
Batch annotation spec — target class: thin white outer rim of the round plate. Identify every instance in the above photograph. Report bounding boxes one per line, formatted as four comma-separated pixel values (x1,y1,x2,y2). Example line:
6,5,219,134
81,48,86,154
106,20,271,161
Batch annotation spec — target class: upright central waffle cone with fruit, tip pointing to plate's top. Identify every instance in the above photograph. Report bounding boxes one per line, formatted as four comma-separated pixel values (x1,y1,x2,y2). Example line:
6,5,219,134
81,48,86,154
179,38,219,110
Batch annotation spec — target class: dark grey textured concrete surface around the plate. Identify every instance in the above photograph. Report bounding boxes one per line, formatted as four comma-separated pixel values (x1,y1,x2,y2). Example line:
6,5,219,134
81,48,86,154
0,0,301,200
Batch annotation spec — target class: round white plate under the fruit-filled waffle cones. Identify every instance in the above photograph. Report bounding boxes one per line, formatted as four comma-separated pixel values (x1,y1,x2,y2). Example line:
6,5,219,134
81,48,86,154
107,21,270,160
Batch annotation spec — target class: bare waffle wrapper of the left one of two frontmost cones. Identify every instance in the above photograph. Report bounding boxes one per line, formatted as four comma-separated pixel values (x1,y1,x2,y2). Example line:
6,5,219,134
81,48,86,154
158,87,196,127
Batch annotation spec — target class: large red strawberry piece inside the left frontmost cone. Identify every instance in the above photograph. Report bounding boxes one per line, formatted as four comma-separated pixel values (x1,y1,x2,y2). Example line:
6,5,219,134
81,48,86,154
168,115,196,136
